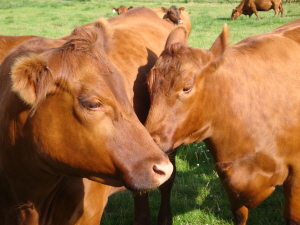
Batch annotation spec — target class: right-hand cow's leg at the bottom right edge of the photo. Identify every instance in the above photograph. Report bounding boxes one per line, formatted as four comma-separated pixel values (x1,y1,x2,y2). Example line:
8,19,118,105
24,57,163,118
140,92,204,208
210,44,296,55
283,176,300,225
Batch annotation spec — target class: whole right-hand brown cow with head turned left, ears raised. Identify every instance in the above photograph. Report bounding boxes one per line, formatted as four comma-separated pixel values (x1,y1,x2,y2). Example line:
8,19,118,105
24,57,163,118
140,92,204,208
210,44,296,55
145,20,300,225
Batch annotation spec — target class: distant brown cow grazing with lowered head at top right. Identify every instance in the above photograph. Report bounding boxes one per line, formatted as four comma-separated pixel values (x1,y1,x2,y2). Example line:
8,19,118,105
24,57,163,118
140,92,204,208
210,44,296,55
231,0,283,20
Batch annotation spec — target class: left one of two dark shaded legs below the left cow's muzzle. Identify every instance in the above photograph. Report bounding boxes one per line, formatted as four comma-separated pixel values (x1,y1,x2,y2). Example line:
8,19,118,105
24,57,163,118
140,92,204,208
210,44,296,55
133,192,151,225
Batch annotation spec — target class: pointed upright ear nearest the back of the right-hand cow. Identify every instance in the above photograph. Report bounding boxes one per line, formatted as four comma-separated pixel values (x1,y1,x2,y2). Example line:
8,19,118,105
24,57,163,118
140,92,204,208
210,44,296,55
210,24,229,57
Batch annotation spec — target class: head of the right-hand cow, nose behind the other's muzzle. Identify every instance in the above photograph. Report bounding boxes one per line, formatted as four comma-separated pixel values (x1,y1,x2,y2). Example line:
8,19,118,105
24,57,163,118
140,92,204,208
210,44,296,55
145,26,228,151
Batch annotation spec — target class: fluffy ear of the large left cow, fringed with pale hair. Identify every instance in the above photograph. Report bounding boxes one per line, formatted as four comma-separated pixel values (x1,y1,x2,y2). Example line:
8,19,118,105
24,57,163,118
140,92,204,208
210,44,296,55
11,56,50,105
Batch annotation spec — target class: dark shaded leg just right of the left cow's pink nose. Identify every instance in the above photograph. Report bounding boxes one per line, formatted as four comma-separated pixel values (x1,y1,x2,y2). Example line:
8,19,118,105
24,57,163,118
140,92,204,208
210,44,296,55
158,149,177,225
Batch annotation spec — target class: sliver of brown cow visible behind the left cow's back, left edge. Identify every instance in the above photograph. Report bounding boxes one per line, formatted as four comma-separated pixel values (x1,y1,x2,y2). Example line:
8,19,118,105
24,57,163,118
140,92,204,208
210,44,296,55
0,35,37,64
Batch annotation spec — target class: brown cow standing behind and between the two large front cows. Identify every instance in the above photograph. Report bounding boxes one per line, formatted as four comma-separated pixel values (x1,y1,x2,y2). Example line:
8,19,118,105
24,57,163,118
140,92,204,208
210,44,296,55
109,7,178,225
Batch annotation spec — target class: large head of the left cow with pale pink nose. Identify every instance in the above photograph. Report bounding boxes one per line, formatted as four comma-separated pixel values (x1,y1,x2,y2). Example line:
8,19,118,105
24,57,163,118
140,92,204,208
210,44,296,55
8,22,173,190
